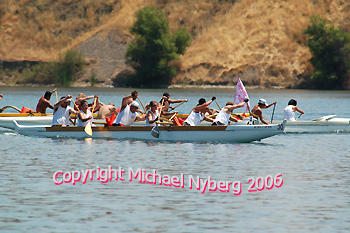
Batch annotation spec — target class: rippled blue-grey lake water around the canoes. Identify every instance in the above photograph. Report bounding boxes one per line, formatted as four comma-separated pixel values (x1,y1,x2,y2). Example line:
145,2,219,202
0,88,350,232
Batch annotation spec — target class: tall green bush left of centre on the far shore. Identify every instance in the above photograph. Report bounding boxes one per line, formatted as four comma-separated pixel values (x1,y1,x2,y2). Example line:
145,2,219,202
125,6,191,87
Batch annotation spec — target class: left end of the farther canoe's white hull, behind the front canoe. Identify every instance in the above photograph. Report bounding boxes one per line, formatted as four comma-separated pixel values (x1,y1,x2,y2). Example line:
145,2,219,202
0,115,52,129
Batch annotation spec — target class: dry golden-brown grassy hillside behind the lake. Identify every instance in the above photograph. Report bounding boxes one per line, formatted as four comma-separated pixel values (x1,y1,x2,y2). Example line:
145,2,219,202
0,0,350,86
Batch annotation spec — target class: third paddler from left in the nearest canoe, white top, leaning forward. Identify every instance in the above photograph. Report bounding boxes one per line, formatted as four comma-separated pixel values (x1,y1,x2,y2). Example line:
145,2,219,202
113,100,146,126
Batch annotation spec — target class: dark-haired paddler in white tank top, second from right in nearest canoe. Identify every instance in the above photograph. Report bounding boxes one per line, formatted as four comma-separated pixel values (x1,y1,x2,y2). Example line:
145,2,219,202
182,97,216,126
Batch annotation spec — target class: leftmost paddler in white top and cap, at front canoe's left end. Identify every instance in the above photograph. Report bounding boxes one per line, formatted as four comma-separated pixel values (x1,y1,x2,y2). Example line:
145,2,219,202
52,95,79,126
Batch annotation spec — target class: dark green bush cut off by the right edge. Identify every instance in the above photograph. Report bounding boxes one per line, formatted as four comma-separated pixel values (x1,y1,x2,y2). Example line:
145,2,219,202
304,15,350,89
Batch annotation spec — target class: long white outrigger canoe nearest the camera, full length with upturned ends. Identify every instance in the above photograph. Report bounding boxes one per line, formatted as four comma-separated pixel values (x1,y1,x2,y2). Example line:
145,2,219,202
13,121,285,143
